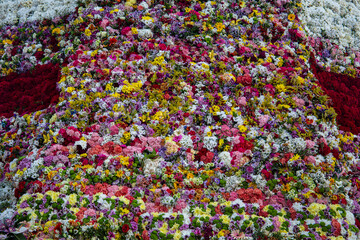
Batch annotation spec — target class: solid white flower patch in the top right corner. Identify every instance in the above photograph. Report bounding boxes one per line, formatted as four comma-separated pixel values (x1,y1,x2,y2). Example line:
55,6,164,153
299,0,360,50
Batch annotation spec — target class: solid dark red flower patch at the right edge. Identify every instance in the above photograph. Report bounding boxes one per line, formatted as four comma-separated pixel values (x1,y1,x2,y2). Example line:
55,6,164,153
311,57,360,134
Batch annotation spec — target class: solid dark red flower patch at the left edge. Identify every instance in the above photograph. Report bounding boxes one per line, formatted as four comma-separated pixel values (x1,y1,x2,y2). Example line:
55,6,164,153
0,63,60,117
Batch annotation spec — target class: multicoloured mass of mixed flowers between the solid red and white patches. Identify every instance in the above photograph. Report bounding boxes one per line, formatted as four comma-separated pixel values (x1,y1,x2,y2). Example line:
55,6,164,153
0,0,360,239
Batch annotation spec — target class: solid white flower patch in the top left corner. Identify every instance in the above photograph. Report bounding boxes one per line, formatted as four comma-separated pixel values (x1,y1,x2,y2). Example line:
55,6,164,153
0,0,82,26
